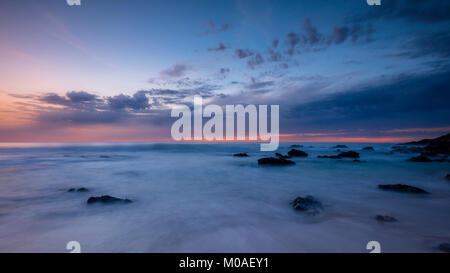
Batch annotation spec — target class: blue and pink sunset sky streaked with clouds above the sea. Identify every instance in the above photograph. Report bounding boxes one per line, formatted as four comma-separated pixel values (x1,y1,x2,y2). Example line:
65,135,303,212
0,0,450,142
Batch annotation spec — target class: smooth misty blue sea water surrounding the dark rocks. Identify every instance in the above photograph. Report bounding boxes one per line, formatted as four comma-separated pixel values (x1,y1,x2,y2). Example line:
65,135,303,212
0,143,450,252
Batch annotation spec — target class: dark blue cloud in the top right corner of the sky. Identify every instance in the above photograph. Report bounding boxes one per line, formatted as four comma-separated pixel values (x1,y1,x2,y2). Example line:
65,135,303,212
350,0,450,23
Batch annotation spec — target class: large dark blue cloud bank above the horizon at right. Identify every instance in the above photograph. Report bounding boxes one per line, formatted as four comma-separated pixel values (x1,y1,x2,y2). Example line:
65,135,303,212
285,70,450,129
